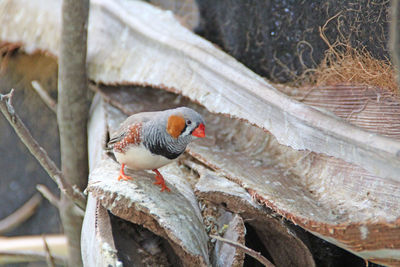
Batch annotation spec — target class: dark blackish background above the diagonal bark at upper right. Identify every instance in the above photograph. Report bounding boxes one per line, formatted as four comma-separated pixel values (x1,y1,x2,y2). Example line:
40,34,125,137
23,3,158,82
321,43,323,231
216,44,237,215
196,0,390,82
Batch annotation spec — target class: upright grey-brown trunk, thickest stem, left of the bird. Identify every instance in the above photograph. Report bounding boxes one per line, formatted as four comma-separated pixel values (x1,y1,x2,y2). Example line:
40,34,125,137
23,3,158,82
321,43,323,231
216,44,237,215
57,0,89,267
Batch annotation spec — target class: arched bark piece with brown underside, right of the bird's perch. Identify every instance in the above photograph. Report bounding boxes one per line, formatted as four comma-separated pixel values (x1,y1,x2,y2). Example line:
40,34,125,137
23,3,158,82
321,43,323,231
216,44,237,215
191,164,315,267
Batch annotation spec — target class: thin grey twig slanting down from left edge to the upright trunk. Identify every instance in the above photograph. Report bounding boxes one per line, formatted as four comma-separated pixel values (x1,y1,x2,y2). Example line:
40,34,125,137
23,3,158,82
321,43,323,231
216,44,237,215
0,89,86,209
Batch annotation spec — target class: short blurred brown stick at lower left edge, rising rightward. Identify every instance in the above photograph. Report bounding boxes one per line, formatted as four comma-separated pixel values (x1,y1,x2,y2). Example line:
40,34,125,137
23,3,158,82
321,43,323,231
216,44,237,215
0,194,42,234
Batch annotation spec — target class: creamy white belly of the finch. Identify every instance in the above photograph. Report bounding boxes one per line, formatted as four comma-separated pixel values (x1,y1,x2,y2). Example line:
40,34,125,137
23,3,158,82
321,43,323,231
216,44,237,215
114,144,172,170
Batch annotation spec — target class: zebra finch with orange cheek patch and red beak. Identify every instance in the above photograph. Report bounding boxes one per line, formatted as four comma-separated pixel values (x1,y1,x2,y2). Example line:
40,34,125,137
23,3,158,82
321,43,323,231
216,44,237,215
107,107,205,192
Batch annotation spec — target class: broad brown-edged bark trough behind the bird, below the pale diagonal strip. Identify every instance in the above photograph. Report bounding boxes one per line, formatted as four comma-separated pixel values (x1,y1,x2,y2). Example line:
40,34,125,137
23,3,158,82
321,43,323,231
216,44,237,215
101,87,400,265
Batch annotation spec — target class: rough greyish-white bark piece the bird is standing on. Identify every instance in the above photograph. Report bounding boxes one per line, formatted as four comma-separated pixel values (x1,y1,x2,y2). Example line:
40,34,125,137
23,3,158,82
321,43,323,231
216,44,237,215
87,158,208,266
